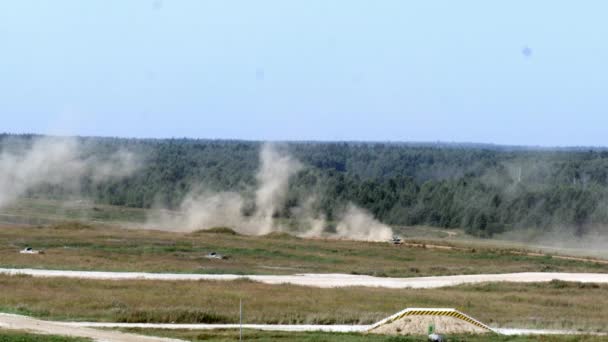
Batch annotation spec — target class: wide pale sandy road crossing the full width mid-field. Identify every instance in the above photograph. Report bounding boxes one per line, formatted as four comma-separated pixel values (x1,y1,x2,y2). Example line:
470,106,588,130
0,268,608,288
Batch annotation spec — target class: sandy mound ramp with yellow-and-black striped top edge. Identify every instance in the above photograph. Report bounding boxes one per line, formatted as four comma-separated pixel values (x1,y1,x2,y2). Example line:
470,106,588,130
368,308,495,335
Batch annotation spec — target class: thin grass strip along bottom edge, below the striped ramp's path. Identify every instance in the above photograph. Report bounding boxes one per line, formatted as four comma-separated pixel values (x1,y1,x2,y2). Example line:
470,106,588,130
119,329,606,342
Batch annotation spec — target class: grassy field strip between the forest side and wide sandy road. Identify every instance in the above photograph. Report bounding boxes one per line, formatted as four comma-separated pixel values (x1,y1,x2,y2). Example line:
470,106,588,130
0,222,608,277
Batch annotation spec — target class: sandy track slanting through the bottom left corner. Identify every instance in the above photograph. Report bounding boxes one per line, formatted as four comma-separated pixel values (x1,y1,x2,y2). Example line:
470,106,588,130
0,313,183,342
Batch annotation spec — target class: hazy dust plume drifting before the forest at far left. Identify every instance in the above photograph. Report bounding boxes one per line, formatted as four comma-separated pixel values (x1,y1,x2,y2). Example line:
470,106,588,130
0,137,138,207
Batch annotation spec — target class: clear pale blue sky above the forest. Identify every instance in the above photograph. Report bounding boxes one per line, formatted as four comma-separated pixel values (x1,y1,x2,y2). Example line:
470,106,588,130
0,0,608,145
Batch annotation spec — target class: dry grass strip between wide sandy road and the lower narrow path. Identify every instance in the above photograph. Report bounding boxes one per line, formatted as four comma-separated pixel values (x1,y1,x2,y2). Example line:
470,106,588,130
0,276,608,331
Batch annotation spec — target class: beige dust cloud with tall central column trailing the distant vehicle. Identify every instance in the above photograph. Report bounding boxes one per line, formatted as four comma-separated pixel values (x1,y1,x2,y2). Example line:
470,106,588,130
146,144,392,241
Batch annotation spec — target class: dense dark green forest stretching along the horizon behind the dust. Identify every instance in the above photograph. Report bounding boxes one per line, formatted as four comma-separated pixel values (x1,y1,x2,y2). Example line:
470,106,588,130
0,134,608,237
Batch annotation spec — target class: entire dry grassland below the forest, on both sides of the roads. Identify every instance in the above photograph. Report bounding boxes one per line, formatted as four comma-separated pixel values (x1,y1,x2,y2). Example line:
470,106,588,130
0,200,608,341
